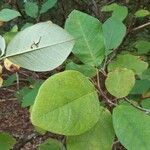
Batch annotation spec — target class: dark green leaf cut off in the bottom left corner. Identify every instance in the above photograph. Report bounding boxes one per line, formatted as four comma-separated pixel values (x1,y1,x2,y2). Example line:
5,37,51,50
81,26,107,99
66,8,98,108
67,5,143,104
0,133,16,150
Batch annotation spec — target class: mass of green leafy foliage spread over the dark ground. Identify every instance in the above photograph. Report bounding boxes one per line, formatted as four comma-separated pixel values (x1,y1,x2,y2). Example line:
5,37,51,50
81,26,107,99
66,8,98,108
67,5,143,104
0,0,150,150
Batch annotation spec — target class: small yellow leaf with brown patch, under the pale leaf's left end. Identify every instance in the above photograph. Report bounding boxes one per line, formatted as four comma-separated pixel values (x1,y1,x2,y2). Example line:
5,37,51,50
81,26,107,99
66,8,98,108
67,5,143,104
4,58,20,72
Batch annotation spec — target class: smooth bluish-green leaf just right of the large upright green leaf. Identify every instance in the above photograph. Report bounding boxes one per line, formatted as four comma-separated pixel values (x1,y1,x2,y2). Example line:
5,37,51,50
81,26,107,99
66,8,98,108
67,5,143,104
102,18,126,54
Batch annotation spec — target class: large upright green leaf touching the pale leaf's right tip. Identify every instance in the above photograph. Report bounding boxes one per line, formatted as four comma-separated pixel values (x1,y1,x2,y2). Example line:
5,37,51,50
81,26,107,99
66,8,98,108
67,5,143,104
65,10,104,66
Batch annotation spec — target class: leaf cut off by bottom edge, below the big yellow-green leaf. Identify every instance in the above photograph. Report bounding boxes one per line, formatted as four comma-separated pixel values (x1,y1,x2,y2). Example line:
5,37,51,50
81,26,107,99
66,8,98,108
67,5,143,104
38,138,65,150
